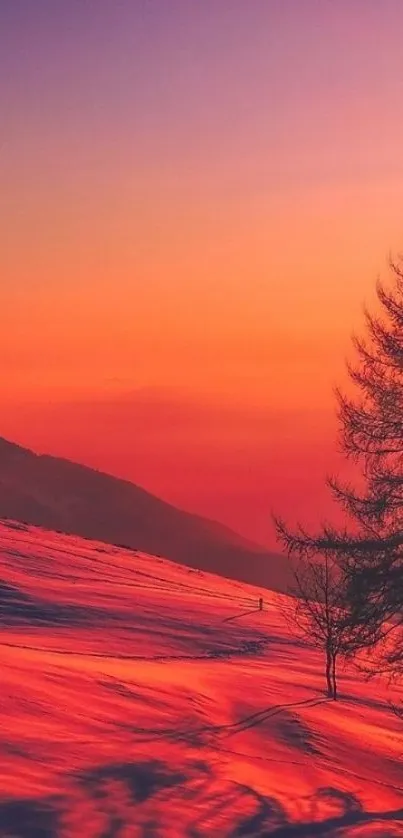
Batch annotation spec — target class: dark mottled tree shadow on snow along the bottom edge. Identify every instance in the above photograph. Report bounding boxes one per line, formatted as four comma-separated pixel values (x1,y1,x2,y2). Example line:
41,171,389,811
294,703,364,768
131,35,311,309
0,760,403,838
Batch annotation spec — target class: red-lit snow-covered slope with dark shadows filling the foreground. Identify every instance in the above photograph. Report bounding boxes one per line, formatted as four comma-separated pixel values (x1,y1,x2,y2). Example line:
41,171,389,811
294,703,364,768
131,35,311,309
0,522,403,838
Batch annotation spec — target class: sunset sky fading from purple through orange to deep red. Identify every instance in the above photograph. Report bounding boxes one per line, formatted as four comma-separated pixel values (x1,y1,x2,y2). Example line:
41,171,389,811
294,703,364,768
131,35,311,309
0,0,403,546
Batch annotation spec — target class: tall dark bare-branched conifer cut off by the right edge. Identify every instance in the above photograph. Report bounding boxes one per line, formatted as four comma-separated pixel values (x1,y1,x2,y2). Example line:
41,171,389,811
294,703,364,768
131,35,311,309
276,262,403,688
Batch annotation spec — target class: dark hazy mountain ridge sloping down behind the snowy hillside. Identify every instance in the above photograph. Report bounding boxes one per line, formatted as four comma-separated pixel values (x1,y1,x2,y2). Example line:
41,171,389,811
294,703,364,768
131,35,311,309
0,437,289,591
